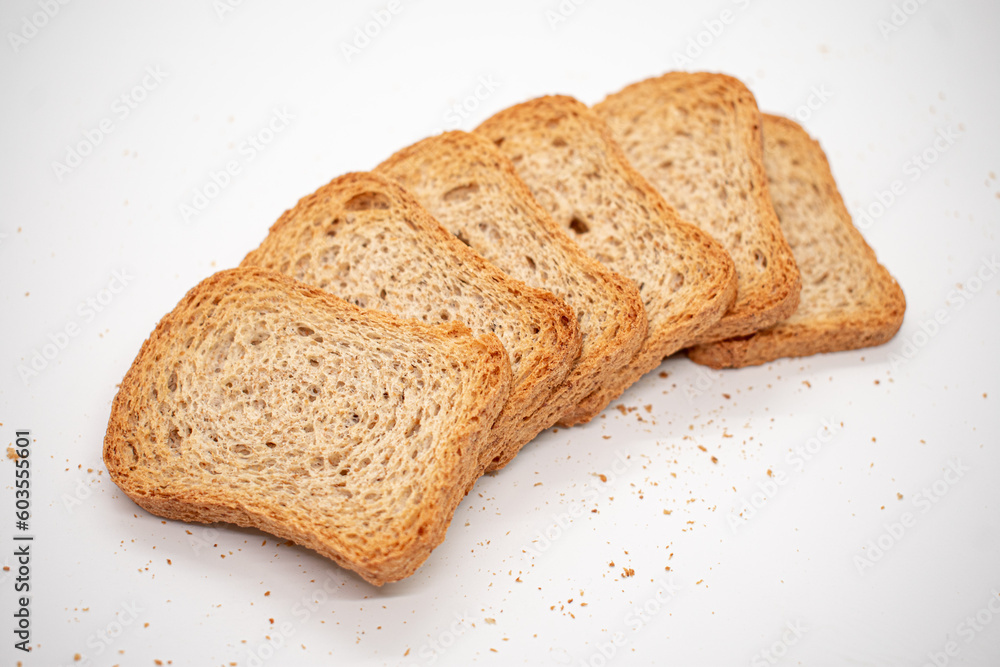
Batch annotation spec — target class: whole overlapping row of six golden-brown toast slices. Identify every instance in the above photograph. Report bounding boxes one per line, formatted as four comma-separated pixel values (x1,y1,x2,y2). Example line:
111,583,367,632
104,72,906,585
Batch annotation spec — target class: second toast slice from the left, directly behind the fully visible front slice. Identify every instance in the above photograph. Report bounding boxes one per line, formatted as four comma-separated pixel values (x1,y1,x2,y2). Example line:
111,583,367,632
242,173,581,470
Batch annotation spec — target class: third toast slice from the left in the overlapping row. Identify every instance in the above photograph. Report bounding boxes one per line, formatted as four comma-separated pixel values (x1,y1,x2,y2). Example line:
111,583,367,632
375,131,647,426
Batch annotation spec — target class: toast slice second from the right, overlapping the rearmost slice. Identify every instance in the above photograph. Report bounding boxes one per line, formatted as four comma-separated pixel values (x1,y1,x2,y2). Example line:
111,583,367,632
594,72,801,342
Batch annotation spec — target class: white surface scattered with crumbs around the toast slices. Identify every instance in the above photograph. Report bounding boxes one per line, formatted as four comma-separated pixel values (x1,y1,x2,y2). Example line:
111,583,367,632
0,0,1000,667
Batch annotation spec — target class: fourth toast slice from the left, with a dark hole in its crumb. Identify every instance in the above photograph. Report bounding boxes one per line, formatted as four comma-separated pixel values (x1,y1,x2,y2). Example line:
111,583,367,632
476,96,736,421
